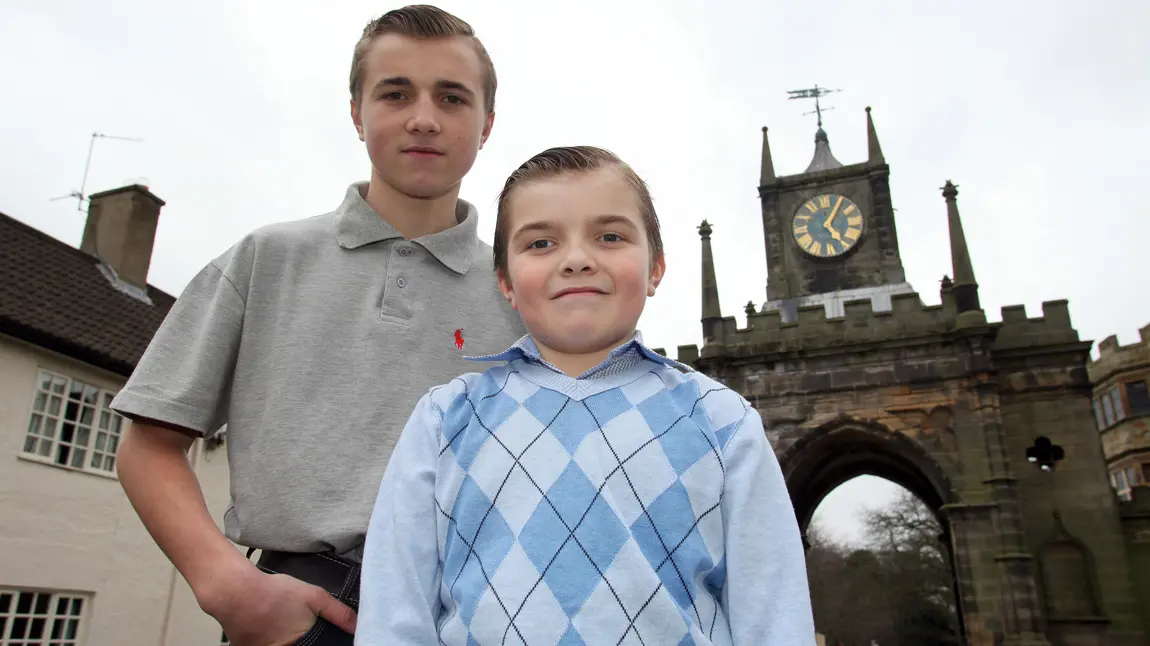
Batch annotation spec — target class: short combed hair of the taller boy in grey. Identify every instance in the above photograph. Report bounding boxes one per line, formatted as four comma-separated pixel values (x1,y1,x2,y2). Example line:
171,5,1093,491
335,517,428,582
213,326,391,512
350,5,497,114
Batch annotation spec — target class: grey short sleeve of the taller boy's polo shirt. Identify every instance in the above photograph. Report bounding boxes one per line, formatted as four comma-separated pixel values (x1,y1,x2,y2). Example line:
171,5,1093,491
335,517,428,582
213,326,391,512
112,256,245,436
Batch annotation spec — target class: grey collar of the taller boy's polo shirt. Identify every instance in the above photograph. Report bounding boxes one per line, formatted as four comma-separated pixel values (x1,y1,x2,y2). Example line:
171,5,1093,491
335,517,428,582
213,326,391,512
335,182,480,274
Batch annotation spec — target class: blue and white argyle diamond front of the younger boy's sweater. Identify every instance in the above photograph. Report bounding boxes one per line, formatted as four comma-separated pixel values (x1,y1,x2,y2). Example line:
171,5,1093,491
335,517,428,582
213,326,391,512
436,370,741,646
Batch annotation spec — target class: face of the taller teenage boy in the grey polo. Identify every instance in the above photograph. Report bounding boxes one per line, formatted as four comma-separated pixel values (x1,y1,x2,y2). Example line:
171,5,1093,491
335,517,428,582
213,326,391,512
352,33,495,199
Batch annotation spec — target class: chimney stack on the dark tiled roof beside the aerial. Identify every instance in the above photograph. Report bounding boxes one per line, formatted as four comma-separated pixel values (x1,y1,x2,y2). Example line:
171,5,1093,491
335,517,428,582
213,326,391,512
79,184,164,289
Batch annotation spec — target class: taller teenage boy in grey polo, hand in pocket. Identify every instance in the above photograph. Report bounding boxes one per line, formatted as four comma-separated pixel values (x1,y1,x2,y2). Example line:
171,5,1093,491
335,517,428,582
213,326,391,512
114,6,523,646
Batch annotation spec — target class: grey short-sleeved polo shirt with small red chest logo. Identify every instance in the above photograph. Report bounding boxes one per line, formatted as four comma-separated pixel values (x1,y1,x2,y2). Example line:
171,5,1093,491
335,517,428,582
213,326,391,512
112,183,524,554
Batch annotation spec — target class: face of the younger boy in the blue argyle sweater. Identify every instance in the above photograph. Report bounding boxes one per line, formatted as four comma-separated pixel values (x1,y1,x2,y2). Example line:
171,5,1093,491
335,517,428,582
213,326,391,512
499,168,665,354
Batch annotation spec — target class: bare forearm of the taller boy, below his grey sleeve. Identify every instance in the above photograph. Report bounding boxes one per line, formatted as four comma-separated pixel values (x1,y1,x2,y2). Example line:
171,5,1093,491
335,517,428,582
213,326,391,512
116,423,254,612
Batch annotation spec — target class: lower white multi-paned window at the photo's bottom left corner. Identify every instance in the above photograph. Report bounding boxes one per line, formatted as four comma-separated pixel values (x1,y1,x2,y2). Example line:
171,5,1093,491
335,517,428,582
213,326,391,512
0,587,89,646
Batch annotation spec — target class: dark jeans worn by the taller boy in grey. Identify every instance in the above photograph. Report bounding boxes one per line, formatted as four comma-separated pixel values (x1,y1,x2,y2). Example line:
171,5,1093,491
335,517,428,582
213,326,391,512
256,552,360,646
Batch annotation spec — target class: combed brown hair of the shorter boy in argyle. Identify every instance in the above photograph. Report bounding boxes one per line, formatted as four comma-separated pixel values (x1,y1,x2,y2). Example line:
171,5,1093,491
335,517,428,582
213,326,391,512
492,146,662,272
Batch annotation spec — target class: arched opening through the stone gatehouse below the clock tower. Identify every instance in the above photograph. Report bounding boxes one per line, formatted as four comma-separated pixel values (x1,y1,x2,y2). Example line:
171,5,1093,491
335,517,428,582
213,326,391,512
780,418,966,645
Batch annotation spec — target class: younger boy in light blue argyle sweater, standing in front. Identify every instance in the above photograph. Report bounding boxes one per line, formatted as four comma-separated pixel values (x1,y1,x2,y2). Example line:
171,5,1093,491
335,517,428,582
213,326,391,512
355,147,814,646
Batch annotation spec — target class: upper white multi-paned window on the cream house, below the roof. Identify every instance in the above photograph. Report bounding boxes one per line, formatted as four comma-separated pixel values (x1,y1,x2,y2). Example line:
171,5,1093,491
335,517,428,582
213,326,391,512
20,369,127,478
